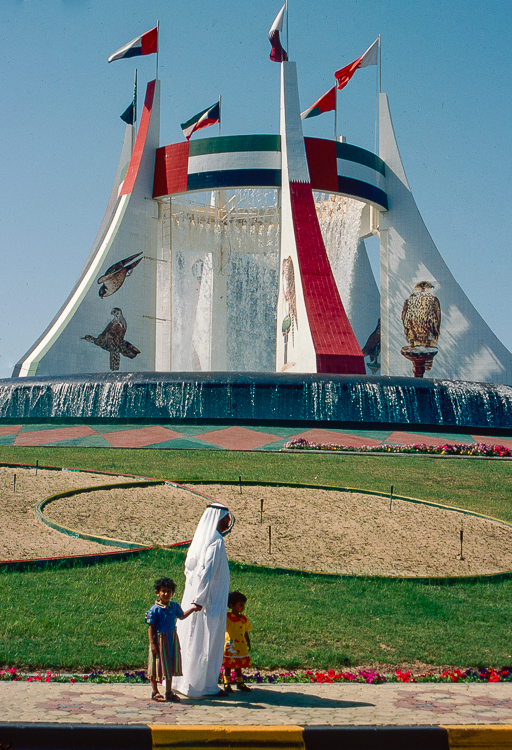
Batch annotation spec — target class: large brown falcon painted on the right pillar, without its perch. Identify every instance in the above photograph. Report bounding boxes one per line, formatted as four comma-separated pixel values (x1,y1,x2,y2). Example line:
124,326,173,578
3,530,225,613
402,281,441,346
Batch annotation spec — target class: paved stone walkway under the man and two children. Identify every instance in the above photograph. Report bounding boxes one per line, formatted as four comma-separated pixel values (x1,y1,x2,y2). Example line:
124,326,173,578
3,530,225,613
5,680,512,724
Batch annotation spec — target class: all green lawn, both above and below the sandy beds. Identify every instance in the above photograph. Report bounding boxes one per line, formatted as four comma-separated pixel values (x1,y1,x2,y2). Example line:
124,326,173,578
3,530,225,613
0,447,512,671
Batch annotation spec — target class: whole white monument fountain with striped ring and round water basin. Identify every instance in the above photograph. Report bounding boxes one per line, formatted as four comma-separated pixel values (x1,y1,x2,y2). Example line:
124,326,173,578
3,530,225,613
0,62,512,440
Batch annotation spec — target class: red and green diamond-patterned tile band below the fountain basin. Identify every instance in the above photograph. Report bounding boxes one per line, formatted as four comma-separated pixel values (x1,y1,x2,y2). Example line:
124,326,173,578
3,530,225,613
0,422,512,451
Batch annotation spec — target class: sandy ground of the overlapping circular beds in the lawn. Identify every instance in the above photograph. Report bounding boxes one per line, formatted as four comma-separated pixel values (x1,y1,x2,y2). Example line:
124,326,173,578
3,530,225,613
4,469,512,576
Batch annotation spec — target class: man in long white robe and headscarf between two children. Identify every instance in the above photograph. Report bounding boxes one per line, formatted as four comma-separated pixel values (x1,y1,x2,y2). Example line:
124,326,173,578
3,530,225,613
173,503,230,698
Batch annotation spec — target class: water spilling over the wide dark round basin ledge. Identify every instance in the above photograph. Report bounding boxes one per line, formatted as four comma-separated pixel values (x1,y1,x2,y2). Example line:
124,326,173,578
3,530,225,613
0,372,512,430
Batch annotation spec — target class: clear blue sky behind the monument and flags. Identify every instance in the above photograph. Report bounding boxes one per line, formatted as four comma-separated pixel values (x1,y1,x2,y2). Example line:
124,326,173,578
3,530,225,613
0,0,512,378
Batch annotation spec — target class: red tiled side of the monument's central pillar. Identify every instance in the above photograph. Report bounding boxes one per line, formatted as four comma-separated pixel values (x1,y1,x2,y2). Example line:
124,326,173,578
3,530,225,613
290,182,365,375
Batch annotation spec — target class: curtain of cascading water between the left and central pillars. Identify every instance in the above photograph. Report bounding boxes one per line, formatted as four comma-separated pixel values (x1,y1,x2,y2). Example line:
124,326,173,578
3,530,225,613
157,190,279,372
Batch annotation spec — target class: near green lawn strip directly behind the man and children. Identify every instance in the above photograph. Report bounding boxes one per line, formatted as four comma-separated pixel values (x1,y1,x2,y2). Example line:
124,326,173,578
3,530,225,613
0,550,512,672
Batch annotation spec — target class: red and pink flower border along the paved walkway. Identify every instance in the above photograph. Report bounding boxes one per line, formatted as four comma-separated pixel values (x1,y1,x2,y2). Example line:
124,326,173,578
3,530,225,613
4,667,512,685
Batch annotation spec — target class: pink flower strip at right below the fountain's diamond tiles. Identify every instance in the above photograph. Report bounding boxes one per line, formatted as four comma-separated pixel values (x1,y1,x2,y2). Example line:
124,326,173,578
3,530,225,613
284,438,512,458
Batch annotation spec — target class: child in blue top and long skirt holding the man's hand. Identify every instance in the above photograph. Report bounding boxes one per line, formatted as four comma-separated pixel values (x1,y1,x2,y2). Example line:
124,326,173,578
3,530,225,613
146,578,201,703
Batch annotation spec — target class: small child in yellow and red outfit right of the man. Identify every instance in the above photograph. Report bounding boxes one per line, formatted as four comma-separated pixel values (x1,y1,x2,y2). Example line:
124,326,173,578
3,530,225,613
222,591,252,693
